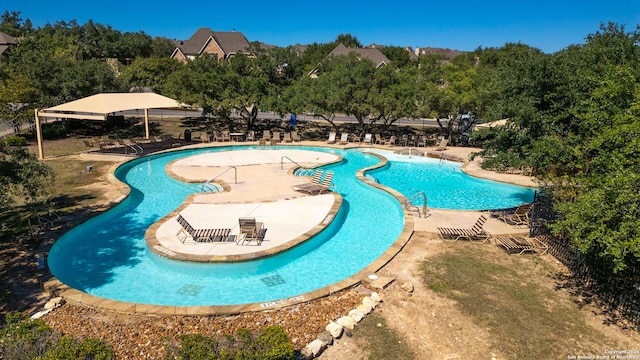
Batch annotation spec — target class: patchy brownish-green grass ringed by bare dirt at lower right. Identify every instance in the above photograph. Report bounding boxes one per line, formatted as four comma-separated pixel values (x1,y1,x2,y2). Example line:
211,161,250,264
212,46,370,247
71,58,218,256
422,244,632,359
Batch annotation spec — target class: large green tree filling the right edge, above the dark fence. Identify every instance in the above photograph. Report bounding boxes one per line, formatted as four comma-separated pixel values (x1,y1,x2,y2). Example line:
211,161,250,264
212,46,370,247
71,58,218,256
480,23,640,273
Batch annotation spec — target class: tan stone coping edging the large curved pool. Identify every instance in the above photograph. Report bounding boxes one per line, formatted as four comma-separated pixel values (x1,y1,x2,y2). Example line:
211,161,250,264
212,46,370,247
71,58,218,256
43,146,414,316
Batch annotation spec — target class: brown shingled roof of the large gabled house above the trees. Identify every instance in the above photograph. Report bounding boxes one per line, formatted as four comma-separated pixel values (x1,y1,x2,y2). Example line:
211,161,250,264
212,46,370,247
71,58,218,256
178,28,249,55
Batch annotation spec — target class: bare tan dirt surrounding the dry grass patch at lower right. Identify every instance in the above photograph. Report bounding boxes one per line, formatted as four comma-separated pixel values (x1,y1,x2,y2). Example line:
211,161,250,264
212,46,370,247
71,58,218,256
321,233,640,359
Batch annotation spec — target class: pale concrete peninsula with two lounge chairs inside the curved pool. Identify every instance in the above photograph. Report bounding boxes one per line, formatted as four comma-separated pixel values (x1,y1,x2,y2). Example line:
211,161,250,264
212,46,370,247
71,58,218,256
145,149,342,262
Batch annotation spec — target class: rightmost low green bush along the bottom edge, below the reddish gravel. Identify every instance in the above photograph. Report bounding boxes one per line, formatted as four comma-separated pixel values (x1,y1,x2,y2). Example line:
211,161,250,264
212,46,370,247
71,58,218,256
174,326,295,360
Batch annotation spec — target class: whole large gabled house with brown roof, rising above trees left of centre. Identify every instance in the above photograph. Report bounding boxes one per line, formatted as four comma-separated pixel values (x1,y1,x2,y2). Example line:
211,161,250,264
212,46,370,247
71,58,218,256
171,28,249,61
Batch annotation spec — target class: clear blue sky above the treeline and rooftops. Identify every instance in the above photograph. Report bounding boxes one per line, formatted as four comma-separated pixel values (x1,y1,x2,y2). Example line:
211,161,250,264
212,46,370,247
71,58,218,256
0,0,640,53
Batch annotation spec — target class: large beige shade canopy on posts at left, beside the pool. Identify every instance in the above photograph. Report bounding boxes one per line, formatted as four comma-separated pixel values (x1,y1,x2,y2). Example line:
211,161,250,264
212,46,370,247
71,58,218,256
35,93,196,159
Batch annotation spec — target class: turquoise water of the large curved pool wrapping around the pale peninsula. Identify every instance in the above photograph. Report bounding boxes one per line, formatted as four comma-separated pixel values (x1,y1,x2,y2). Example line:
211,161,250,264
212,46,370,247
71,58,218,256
48,147,536,306
